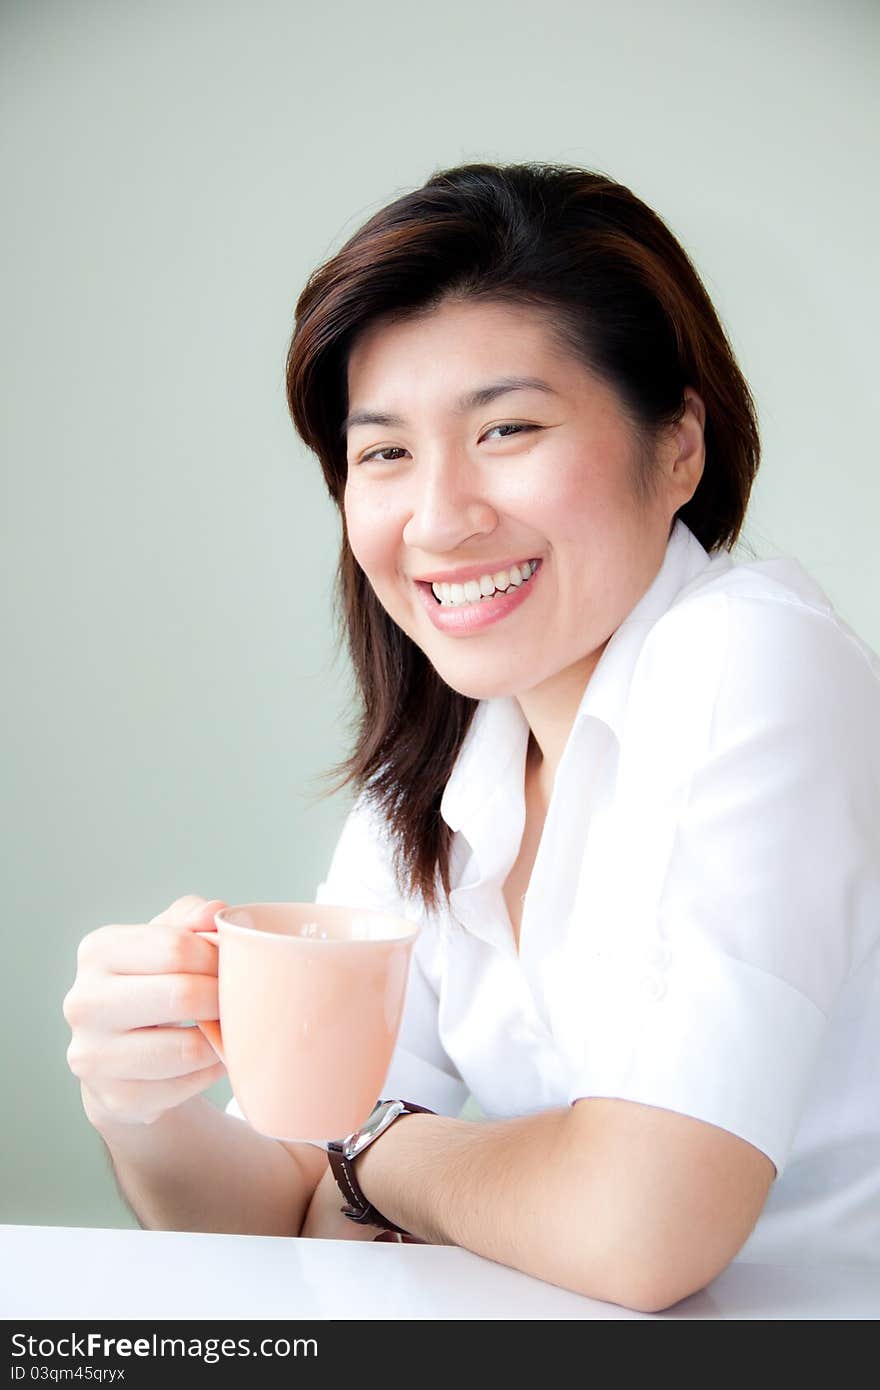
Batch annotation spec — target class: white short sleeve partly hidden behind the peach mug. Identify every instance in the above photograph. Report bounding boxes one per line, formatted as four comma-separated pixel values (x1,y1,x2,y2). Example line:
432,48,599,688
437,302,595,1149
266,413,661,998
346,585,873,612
227,794,468,1118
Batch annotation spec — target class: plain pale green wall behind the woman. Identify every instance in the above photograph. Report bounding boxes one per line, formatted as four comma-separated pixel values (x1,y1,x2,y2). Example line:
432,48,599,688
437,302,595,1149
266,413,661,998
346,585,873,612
0,0,880,1226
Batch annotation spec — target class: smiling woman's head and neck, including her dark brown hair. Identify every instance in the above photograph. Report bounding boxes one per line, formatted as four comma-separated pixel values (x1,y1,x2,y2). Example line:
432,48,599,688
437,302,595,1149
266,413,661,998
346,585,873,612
288,164,759,909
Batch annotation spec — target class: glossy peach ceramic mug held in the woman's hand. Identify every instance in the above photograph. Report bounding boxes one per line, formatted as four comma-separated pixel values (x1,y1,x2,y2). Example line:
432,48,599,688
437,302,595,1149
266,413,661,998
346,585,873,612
196,902,418,1148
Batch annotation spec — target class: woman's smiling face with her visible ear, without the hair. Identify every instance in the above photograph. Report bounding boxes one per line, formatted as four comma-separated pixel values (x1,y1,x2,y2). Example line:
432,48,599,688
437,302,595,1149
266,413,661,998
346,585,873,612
343,303,703,699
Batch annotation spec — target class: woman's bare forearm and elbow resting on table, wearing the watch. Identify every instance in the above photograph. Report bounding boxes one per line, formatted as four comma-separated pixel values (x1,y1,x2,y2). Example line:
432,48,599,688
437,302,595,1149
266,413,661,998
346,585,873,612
346,1097,776,1312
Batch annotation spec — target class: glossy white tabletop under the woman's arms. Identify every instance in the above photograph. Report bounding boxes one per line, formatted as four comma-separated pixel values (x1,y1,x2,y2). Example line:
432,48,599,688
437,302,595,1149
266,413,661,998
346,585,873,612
0,1226,880,1322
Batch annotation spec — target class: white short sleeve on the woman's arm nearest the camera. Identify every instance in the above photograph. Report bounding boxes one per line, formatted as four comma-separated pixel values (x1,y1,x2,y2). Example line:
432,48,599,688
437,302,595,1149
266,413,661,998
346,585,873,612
569,595,880,1177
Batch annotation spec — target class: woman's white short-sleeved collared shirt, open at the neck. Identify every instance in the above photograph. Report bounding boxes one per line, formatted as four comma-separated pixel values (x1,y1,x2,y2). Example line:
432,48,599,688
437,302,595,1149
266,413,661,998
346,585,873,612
231,518,880,1262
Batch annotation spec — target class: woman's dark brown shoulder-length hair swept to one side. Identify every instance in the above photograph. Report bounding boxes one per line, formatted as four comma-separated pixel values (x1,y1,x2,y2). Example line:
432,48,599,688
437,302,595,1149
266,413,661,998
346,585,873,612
286,163,760,910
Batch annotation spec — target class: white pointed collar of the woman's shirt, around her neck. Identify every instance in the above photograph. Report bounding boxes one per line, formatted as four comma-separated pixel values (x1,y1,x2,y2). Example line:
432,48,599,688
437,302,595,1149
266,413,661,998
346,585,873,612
441,517,733,830
